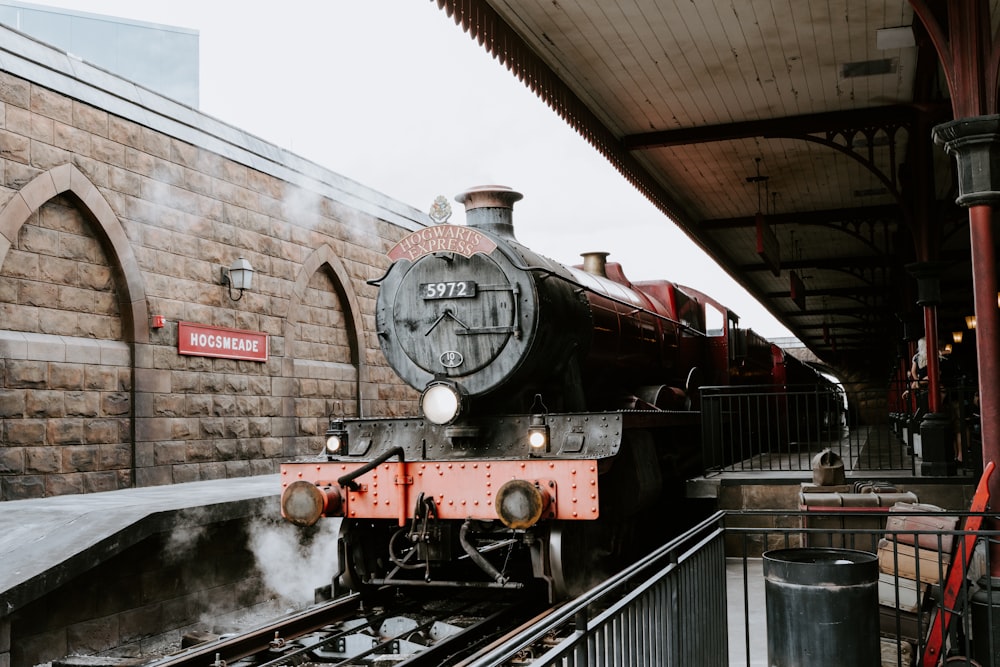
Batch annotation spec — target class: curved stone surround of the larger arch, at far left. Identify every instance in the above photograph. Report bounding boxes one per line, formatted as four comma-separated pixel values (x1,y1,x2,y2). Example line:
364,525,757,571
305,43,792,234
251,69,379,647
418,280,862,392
0,164,149,343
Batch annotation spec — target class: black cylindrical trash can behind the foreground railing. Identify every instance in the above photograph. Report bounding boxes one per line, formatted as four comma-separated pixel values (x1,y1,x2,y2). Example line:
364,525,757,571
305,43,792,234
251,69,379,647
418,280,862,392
763,548,881,667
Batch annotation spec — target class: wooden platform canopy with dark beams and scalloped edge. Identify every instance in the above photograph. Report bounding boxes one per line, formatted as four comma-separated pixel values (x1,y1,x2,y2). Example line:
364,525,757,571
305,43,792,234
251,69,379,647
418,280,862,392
437,0,984,379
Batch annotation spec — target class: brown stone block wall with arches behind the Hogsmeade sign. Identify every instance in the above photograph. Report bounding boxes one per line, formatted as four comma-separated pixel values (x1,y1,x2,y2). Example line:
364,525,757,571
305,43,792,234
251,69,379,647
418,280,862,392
0,60,421,500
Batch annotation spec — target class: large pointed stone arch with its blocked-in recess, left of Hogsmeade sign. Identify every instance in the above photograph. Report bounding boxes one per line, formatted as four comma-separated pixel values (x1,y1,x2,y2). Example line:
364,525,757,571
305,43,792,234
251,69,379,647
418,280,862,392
0,164,150,499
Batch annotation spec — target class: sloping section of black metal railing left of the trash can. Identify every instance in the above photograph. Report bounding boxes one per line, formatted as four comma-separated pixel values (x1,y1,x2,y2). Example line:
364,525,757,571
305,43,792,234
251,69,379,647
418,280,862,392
460,515,729,667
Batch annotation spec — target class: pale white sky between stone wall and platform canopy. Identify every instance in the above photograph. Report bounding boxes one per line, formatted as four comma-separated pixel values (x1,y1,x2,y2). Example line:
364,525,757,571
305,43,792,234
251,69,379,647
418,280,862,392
23,0,791,337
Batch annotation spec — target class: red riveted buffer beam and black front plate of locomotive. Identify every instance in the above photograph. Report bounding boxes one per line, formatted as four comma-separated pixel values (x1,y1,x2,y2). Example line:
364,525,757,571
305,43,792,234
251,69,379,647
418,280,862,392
281,412,644,528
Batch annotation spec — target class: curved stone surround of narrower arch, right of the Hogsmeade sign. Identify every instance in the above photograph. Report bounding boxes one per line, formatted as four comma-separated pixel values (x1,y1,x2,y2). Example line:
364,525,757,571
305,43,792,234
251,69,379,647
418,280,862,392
283,244,371,453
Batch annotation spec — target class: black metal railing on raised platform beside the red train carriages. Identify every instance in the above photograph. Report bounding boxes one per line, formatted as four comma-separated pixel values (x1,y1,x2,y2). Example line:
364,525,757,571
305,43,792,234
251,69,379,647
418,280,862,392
701,385,915,475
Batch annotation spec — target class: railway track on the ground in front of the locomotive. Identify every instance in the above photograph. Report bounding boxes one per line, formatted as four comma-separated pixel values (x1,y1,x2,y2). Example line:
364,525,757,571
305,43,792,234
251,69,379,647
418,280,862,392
147,594,550,667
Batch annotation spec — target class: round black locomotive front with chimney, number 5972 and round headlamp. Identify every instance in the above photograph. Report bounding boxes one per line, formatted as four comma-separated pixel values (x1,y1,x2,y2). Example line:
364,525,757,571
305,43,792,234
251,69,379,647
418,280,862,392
376,188,592,423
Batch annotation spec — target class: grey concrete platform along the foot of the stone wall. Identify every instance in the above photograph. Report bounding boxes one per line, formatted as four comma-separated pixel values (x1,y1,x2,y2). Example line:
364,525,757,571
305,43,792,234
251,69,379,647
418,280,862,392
0,475,281,618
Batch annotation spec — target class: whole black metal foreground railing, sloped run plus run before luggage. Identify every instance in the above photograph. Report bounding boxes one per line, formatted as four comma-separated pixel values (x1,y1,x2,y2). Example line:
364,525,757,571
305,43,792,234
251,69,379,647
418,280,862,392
469,508,1000,667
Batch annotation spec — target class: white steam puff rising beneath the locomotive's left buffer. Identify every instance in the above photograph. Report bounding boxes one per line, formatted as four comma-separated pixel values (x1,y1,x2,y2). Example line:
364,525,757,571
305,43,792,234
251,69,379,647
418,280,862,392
249,519,340,606
